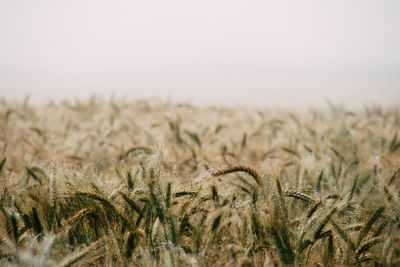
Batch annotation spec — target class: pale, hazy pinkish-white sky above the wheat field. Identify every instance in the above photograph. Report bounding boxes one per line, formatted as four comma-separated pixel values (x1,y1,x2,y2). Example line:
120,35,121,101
0,0,400,106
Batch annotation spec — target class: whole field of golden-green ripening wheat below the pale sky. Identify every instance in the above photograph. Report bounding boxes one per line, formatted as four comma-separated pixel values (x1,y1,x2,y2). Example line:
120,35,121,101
0,98,400,266
